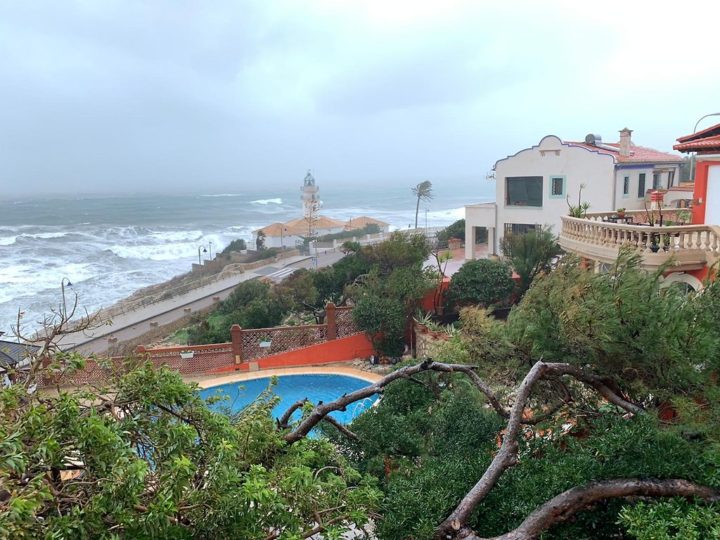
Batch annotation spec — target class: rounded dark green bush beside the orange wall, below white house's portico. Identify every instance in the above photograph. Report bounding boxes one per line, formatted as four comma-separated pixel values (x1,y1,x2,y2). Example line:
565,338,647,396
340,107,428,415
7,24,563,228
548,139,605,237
446,259,515,307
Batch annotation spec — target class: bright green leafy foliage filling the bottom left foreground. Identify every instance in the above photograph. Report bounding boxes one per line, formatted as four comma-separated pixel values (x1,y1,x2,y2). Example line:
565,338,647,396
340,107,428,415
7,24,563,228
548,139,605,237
0,365,378,540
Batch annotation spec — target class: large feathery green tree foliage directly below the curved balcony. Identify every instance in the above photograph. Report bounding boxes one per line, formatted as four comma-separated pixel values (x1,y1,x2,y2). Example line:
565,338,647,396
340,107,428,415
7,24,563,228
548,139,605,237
508,252,720,401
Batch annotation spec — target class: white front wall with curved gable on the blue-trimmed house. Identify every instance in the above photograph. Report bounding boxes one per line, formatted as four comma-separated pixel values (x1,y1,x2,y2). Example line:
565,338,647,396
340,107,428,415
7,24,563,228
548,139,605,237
495,135,616,253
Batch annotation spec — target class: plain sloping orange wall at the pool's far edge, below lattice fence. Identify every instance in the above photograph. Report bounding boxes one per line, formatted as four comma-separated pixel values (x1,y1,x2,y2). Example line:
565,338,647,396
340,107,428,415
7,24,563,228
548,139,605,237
214,333,375,373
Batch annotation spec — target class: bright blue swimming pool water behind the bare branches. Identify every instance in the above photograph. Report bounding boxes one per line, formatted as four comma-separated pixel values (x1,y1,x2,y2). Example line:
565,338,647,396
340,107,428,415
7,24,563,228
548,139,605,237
200,375,377,424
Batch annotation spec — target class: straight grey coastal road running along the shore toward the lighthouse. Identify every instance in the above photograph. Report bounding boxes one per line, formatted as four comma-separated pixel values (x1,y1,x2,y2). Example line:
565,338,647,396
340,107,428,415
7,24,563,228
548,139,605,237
61,249,343,354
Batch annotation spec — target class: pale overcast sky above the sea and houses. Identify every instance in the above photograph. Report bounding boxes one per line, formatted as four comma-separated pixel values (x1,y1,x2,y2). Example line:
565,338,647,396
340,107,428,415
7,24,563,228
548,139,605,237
0,0,720,196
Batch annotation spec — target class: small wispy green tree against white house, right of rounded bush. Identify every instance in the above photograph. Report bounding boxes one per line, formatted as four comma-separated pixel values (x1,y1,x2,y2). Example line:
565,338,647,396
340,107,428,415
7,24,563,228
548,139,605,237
500,227,562,295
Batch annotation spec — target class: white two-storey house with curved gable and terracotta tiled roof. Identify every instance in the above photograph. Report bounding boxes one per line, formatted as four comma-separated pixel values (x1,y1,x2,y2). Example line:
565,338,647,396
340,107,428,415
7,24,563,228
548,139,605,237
465,128,692,259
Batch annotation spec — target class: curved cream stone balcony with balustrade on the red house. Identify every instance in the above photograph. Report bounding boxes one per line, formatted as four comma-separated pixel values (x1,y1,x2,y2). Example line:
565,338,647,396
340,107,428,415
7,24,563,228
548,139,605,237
559,210,720,272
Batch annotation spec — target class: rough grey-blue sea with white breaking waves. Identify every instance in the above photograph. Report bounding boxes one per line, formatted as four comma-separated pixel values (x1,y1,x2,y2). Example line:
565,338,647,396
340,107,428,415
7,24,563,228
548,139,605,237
0,179,494,334
